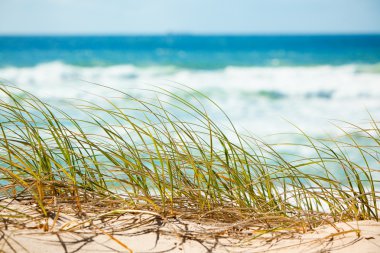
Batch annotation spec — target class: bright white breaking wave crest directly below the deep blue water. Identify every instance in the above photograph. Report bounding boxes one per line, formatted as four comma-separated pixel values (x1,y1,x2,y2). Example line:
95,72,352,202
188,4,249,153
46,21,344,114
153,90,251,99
0,62,380,100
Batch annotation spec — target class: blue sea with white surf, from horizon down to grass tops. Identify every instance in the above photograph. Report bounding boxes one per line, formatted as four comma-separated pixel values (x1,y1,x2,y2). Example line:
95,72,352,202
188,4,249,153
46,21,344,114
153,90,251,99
0,35,380,141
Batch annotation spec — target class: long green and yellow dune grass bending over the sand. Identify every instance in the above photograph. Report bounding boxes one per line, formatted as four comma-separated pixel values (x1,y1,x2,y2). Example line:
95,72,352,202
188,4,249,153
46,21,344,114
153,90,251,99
0,85,380,234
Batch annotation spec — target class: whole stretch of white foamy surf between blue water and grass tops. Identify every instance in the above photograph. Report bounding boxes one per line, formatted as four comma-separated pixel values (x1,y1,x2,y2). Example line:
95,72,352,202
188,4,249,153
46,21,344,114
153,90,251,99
0,62,380,138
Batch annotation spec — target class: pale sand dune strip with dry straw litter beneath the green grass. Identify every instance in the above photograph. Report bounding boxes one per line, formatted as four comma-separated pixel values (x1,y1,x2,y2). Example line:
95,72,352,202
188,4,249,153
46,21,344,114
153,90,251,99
0,200,380,253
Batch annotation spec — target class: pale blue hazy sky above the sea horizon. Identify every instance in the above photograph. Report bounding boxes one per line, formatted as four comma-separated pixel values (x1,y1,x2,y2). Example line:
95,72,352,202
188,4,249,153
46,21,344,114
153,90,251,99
0,0,380,34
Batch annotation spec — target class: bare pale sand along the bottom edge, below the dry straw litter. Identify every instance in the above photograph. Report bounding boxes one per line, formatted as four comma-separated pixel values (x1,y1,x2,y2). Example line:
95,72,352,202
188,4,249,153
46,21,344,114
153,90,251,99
0,217,380,253
